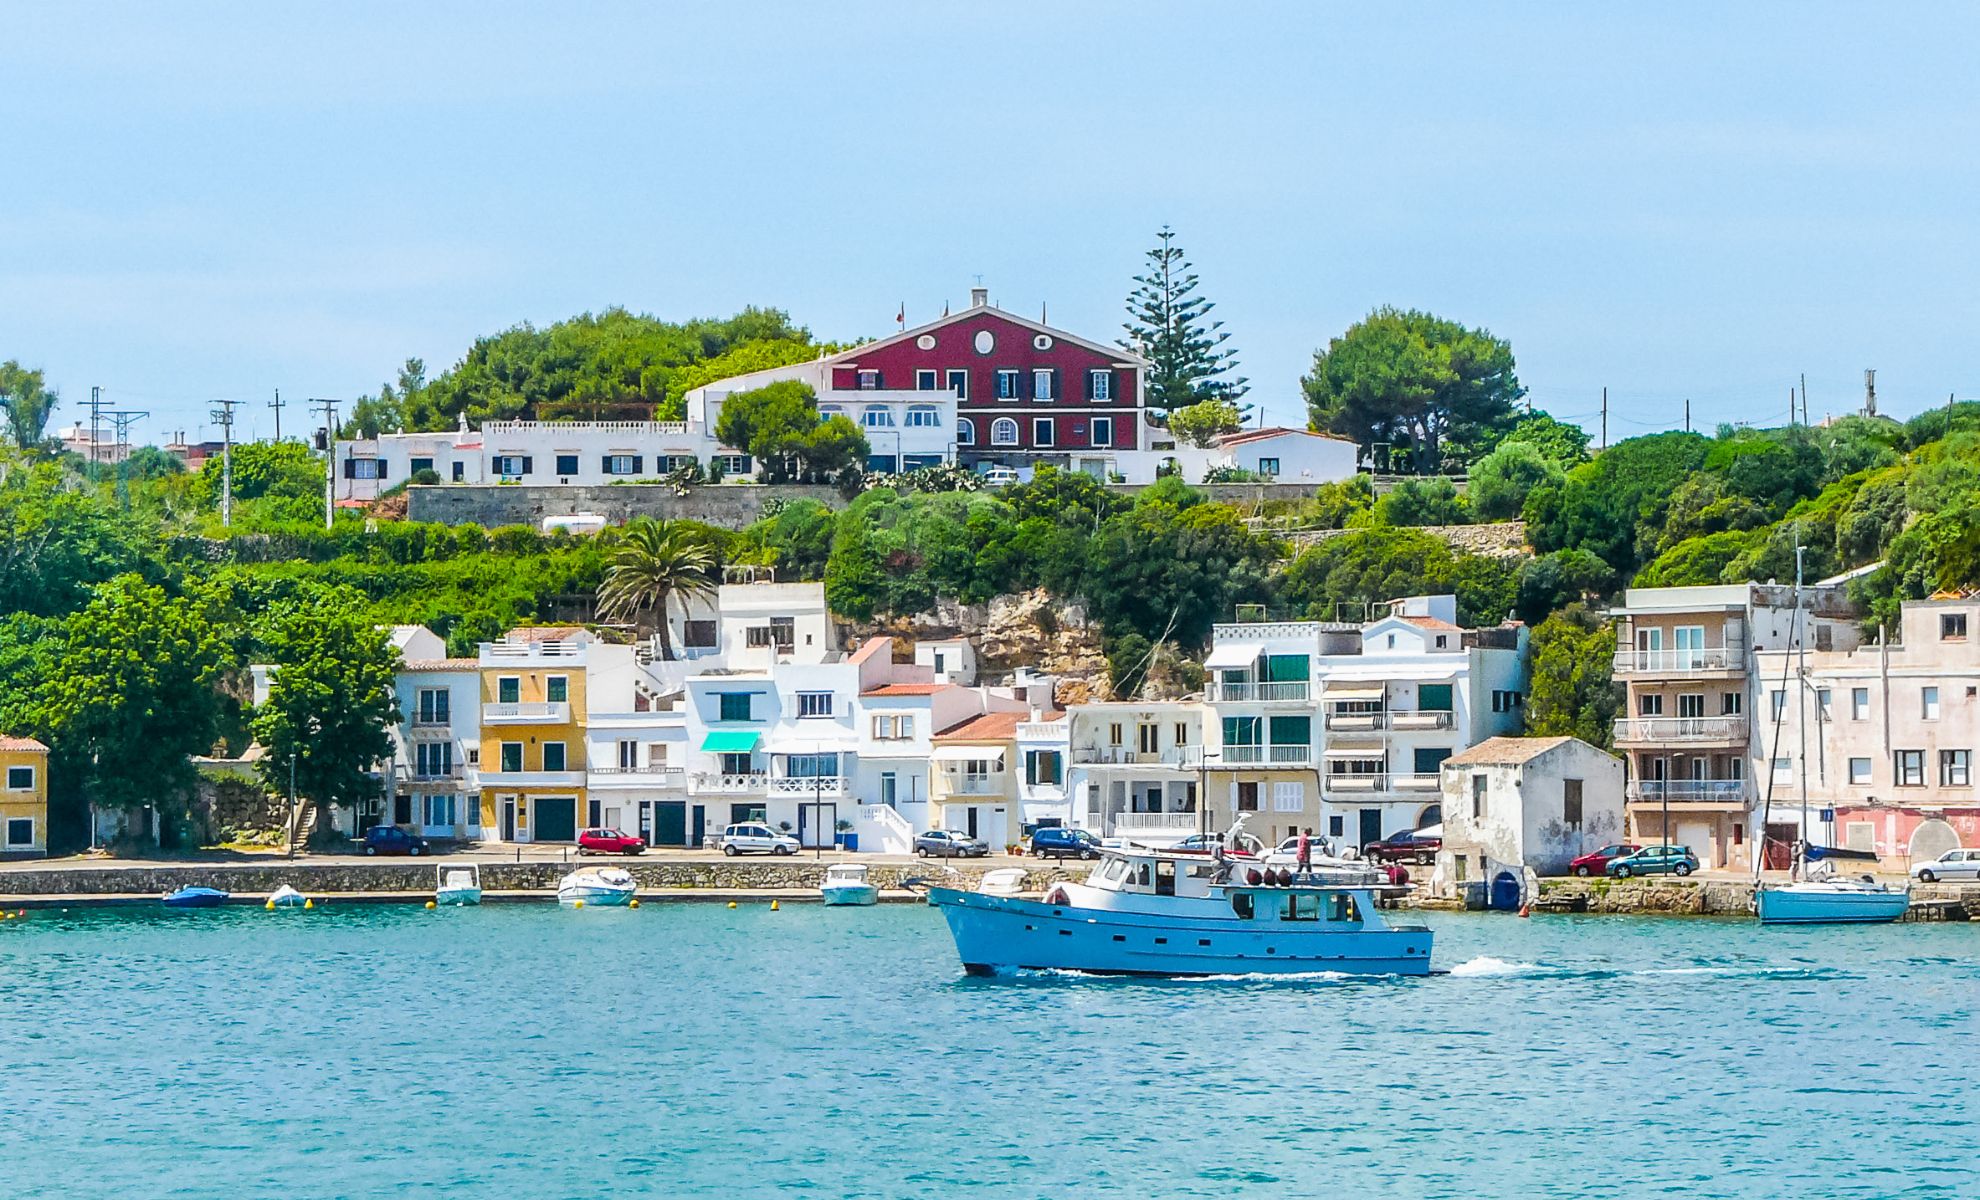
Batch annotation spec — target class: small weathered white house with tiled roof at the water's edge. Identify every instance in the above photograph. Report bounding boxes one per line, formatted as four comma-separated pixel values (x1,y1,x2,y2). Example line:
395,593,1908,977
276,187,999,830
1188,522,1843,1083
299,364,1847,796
1432,737,1624,907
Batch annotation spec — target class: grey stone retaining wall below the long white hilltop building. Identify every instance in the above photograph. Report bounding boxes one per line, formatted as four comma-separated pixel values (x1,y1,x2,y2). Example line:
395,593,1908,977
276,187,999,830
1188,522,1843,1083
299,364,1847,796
406,483,845,529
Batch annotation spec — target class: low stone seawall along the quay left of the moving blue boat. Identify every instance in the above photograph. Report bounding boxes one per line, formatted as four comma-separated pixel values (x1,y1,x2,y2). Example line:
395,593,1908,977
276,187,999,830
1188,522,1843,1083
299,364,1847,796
0,859,1085,899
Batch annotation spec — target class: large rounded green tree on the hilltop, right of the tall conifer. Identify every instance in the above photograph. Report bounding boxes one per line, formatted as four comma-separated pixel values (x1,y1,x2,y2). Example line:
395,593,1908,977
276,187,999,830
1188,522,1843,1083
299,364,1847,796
1301,307,1527,473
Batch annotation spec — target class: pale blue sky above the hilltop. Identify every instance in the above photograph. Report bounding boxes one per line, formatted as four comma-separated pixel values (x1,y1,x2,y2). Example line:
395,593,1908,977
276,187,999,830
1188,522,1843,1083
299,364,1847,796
0,0,1980,442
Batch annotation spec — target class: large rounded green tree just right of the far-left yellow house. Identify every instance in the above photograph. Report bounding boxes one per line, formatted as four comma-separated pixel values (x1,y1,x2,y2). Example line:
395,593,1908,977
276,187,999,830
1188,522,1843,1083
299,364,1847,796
46,574,224,834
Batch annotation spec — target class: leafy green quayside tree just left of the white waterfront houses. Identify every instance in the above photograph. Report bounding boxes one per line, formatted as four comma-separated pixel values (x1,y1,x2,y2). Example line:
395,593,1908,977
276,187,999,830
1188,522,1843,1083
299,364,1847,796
251,588,400,838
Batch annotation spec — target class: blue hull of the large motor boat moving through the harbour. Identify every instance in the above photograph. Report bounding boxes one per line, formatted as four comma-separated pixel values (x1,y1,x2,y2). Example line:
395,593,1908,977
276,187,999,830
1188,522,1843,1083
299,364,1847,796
929,887,1432,976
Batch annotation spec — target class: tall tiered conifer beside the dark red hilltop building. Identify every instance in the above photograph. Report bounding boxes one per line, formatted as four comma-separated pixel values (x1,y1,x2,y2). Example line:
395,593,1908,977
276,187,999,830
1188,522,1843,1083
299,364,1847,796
1123,226,1249,412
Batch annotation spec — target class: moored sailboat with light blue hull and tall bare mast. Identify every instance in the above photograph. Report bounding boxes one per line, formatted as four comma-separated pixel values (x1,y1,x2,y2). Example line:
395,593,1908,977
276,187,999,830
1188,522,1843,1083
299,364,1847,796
1752,547,1911,925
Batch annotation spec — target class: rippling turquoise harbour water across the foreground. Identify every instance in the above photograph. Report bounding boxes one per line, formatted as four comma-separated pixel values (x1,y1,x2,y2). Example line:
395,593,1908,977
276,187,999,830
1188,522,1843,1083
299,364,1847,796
0,905,1980,1200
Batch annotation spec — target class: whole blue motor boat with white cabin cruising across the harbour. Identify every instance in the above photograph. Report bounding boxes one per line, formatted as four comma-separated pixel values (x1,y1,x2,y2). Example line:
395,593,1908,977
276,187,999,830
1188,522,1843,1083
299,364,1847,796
929,846,1432,976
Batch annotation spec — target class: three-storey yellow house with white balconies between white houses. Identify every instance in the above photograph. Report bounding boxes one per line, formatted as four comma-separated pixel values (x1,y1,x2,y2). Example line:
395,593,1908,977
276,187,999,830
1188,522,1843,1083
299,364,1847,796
479,626,596,844
